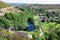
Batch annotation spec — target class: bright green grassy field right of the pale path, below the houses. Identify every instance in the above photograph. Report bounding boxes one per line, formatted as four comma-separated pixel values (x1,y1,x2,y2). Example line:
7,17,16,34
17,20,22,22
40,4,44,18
41,22,60,32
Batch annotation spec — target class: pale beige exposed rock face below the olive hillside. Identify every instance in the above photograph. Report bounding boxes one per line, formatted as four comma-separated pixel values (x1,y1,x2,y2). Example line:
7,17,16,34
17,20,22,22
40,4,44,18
0,7,21,16
